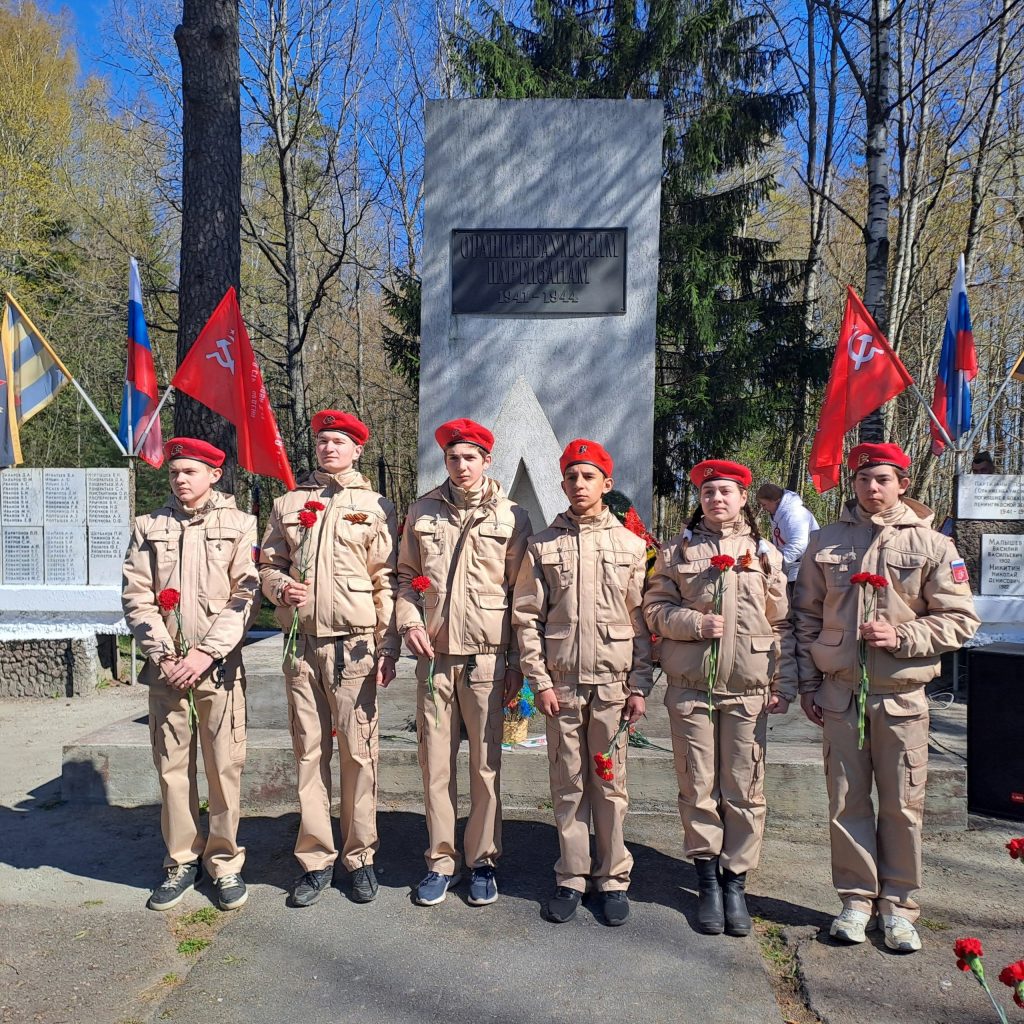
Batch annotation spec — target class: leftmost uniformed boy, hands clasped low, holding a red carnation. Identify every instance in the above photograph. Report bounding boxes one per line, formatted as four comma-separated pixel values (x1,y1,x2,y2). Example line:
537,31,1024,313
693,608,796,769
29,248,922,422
122,437,258,910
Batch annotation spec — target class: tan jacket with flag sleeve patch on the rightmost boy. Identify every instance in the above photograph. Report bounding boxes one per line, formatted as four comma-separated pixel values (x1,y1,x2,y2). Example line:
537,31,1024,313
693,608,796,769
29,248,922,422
794,498,980,693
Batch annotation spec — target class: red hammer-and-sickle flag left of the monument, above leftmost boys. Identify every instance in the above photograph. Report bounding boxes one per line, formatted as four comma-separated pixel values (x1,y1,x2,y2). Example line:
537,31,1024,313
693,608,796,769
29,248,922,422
171,288,295,489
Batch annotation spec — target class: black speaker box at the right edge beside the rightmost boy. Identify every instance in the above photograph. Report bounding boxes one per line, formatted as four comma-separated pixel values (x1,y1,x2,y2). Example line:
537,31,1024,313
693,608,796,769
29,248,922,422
967,643,1024,821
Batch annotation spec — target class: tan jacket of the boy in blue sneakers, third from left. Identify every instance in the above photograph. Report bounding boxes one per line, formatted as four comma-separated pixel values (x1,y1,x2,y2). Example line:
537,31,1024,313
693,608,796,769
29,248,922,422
397,479,530,668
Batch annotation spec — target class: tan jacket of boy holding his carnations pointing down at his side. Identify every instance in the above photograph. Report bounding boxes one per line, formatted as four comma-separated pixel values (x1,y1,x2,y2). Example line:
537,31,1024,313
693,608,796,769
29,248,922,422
513,508,653,696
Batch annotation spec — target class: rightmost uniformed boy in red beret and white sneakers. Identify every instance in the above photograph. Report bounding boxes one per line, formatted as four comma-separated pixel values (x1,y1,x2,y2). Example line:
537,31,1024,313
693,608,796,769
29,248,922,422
794,443,979,952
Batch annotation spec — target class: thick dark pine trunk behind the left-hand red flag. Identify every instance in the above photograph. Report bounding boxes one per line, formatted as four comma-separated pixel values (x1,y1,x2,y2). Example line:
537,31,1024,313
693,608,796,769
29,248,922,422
174,0,242,492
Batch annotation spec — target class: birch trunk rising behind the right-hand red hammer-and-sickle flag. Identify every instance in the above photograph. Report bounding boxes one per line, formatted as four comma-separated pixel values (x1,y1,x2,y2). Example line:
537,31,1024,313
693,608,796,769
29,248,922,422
860,0,892,441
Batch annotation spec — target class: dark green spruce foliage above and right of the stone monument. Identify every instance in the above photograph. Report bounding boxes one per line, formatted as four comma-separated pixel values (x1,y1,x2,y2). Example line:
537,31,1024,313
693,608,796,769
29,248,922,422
450,0,827,496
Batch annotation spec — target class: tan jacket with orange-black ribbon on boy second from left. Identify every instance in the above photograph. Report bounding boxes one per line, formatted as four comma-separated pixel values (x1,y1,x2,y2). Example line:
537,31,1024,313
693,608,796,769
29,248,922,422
259,471,398,657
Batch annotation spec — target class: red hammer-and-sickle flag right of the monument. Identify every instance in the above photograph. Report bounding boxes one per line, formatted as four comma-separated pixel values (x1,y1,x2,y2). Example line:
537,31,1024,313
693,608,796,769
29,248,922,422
808,287,913,494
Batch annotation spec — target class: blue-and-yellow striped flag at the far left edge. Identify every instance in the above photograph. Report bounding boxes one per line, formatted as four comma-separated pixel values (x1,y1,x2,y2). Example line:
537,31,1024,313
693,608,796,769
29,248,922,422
0,295,71,466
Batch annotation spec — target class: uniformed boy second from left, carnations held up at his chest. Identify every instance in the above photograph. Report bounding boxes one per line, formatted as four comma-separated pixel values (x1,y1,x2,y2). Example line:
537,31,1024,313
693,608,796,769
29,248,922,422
259,409,398,906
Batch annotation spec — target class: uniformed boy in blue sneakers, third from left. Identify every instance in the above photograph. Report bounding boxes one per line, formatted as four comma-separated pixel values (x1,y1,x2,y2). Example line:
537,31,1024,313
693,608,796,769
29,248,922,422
397,419,530,906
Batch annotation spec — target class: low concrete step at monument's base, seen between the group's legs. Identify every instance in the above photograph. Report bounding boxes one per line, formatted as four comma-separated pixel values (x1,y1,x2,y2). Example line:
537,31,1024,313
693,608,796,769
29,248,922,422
61,715,967,830
